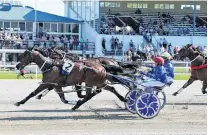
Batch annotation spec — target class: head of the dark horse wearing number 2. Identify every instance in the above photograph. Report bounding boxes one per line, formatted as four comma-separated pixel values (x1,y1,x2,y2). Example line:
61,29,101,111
16,48,38,70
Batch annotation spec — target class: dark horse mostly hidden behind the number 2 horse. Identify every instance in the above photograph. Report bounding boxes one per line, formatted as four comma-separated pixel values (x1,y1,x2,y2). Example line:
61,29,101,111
35,47,136,99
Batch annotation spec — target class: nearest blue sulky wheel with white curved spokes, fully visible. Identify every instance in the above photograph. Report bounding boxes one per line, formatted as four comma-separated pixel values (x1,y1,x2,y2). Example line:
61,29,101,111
135,93,161,119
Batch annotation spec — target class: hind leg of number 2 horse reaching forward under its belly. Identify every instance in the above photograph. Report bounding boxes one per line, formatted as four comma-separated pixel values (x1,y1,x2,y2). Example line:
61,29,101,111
72,88,101,110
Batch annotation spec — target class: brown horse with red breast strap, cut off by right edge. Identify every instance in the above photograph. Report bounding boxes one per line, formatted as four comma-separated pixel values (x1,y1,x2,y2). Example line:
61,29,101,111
173,44,207,96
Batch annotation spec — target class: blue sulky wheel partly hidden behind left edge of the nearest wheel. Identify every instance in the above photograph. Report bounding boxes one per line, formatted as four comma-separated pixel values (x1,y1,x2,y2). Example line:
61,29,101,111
124,90,141,114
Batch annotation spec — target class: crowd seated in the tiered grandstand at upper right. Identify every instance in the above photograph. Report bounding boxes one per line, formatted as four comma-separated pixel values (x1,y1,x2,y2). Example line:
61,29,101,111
100,10,207,36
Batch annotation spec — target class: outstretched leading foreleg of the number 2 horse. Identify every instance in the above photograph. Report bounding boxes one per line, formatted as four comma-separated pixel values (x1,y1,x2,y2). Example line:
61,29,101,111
14,85,48,106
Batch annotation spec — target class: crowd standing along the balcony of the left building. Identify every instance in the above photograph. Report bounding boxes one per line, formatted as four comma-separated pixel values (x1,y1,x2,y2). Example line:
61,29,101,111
0,31,89,50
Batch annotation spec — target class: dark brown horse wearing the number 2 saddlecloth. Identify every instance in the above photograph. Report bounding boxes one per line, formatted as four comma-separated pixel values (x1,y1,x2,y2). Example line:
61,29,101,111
15,49,126,110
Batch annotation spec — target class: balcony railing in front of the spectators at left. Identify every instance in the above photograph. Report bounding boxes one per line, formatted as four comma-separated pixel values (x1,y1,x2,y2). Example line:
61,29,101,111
0,40,95,52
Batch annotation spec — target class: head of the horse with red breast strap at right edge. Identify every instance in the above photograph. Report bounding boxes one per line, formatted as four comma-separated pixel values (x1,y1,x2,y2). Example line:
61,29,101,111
178,44,198,60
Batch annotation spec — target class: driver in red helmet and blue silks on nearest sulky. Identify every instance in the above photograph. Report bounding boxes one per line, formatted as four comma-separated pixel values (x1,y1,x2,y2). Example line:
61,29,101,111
141,57,172,87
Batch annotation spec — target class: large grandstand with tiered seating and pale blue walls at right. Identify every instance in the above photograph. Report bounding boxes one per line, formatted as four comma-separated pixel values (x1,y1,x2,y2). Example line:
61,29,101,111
63,0,207,59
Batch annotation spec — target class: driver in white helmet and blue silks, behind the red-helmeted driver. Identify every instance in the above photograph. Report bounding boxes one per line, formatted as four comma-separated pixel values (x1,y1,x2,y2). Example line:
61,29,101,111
161,52,175,79
